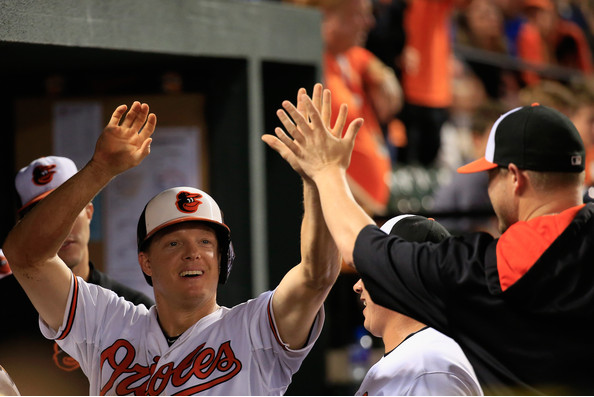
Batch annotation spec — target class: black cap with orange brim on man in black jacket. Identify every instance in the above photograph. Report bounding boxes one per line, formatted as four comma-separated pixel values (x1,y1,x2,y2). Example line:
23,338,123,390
458,103,586,174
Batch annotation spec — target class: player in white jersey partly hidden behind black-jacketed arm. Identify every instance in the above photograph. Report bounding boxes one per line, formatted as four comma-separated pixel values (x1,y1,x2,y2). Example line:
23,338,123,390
353,215,483,396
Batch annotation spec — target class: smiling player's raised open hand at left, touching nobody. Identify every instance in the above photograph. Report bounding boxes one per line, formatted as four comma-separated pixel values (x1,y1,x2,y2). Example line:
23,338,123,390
92,102,157,176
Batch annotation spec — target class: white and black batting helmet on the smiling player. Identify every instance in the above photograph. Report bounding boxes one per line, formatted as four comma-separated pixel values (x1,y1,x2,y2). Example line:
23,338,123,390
136,186,235,284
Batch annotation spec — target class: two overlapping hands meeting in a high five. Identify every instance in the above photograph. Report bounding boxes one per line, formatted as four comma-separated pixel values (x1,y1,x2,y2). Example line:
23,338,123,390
262,84,363,180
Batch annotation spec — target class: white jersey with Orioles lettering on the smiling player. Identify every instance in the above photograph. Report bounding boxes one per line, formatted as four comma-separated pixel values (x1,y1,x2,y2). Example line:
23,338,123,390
40,277,324,396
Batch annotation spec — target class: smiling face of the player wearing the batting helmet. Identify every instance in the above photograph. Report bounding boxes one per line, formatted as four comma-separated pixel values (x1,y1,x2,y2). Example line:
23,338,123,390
138,222,221,308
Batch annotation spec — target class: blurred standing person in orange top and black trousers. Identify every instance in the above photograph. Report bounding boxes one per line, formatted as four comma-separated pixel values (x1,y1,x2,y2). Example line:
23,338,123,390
399,0,469,166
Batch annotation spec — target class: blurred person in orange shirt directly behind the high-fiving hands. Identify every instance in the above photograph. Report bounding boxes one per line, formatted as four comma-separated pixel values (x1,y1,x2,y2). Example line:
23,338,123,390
287,0,402,215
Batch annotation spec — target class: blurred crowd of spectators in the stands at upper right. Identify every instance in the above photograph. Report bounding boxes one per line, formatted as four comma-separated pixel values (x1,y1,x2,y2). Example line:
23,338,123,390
285,0,594,237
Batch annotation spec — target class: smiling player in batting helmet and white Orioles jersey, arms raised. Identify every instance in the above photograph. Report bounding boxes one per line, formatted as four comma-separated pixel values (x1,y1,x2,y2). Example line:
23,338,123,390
4,85,344,395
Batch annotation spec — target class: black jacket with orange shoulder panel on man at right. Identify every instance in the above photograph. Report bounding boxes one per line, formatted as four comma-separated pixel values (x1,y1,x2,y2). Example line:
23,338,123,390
353,204,594,395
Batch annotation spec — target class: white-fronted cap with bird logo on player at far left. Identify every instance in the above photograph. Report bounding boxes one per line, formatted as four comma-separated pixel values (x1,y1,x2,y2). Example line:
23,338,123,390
15,156,78,213
